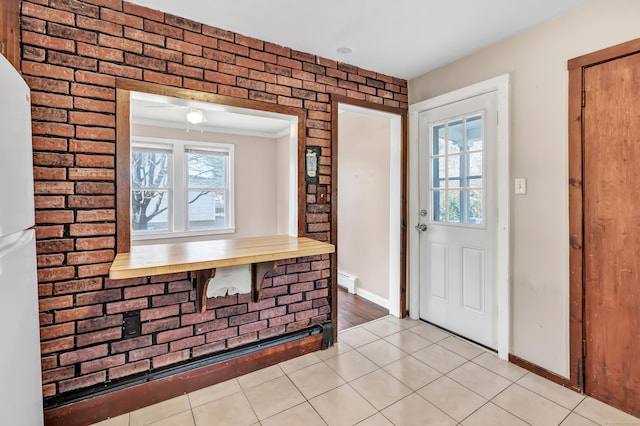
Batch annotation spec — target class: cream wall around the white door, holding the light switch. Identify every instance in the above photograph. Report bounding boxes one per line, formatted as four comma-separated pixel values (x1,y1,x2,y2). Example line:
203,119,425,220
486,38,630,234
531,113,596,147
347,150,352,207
409,0,640,377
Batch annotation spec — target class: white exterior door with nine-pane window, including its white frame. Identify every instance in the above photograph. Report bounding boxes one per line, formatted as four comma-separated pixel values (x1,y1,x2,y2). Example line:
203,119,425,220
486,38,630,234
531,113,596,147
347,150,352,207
409,75,511,359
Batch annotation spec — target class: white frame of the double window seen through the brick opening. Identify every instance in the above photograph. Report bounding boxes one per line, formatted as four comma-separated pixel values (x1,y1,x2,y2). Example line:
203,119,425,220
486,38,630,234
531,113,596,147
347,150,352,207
129,136,236,241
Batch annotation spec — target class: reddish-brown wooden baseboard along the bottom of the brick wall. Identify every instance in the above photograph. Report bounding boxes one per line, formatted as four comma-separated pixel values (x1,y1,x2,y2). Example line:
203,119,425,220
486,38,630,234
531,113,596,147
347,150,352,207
44,334,322,426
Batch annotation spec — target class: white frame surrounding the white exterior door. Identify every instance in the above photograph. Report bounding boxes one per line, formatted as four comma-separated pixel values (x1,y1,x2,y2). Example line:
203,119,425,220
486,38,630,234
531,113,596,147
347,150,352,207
409,74,511,360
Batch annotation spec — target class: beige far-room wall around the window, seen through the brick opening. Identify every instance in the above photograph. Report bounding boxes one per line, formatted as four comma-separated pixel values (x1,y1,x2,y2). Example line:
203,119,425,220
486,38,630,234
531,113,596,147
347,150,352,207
131,124,282,244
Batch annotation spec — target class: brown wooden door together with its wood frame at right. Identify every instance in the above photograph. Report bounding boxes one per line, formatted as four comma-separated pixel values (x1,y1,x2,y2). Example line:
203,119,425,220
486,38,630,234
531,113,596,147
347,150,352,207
569,36,640,416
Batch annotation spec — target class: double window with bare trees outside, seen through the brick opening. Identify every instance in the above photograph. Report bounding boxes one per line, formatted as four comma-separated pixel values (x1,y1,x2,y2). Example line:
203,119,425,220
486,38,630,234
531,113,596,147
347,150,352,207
131,138,235,240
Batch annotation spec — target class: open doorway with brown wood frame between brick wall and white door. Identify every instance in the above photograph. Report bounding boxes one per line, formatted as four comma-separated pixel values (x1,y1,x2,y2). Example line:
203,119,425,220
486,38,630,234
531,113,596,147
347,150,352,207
331,96,406,329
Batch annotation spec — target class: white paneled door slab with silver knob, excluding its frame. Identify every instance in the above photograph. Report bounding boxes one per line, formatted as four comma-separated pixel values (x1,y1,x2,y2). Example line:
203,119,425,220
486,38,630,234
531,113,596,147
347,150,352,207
419,92,498,349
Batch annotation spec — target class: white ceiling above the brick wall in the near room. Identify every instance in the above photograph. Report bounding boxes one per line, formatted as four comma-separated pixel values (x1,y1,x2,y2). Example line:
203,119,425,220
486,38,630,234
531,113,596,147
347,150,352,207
130,0,590,79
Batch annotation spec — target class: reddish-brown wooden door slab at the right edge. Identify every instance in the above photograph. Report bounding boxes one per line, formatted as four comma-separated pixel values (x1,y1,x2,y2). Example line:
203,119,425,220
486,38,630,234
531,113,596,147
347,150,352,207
583,50,640,416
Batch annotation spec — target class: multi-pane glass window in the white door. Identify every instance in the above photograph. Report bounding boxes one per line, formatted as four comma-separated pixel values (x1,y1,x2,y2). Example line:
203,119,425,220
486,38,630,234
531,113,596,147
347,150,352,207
430,114,484,225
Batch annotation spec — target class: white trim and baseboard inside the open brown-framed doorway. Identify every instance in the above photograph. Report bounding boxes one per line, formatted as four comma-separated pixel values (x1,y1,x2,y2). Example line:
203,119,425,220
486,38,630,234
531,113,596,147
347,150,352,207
338,103,402,317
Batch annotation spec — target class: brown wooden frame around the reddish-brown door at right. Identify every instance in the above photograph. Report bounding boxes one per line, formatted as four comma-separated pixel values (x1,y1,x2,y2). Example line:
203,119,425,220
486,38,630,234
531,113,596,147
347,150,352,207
567,39,640,392
